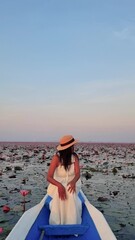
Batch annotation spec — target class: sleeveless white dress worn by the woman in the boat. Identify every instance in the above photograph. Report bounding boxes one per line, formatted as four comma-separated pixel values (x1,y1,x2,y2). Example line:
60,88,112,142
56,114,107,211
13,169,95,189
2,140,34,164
47,155,82,224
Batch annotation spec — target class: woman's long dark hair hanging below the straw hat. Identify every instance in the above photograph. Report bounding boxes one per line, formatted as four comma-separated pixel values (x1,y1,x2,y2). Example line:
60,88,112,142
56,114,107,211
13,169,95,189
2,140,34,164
59,147,73,171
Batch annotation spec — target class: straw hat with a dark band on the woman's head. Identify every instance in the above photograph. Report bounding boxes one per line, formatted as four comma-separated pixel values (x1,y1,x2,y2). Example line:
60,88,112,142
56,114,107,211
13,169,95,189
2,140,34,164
57,135,77,151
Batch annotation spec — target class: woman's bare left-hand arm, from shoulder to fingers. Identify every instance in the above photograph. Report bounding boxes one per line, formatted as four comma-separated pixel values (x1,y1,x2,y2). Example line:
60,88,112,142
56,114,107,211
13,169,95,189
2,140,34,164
47,154,66,200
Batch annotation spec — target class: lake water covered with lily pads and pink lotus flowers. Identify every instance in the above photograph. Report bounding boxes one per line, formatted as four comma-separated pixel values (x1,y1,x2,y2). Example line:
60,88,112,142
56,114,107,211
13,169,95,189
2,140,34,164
0,143,135,240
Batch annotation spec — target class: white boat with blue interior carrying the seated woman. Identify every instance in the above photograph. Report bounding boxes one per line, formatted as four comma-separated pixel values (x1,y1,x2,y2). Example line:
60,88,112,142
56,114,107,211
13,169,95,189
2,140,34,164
6,190,116,240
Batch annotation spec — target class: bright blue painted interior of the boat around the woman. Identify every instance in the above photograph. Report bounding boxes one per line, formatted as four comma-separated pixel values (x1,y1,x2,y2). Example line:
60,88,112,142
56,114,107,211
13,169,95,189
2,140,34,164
25,193,101,240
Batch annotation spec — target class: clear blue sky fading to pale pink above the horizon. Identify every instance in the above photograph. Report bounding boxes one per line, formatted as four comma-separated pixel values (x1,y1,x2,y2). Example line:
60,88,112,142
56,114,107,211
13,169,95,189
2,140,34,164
0,0,135,143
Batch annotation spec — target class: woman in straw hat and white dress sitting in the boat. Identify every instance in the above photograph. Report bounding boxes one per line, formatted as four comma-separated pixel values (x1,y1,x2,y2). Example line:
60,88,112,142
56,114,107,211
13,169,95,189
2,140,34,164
47,135,82,224
